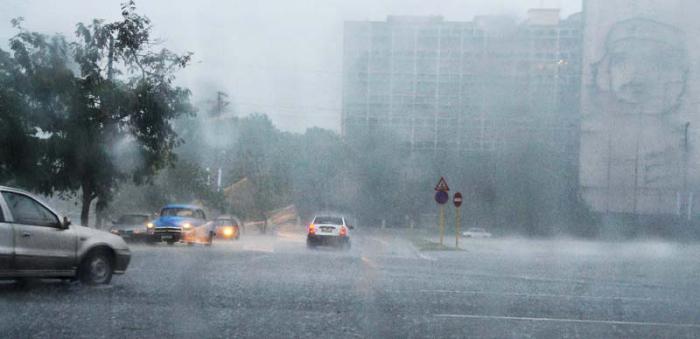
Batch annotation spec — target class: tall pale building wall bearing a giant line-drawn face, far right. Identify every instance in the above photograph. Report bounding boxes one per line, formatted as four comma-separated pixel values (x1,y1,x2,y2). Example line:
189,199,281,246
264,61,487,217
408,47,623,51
579,0,700,219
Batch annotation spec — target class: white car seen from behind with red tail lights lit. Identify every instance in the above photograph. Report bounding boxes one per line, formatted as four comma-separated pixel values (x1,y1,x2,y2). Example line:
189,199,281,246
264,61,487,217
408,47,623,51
306,216,353,249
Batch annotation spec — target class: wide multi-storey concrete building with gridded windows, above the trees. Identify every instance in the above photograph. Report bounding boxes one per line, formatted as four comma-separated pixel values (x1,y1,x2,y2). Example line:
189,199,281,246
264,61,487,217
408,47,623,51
342,9,582,159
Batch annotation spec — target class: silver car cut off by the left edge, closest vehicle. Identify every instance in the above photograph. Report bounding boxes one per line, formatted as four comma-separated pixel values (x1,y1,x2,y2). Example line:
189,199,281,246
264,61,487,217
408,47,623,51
0,186,131,285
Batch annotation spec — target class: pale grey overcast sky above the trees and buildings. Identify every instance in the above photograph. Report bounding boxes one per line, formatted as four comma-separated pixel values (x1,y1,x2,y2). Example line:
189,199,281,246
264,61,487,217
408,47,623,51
0,0,581,131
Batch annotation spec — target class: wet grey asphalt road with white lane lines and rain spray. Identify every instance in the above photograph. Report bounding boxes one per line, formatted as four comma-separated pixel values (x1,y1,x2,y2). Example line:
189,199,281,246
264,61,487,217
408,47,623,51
0,231,700,338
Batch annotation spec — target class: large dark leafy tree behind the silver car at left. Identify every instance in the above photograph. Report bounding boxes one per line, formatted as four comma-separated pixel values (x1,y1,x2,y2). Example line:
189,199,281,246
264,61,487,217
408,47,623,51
3,1,194,224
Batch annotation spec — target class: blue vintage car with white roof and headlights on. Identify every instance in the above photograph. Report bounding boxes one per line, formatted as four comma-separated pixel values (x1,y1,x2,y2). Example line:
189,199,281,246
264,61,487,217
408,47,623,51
147,204,214,245
